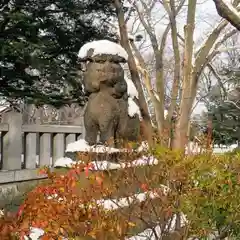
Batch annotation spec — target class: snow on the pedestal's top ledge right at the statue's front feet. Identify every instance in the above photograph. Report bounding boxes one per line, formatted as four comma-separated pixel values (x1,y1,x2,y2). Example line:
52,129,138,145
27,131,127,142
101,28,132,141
66,139,120,153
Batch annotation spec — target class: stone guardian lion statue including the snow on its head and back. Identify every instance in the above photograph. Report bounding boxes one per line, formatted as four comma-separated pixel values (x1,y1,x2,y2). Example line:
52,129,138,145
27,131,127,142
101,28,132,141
78,40,140,146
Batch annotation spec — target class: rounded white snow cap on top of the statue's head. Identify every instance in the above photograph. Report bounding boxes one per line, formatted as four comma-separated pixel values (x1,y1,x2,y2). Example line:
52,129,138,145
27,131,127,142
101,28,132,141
78,40,128,60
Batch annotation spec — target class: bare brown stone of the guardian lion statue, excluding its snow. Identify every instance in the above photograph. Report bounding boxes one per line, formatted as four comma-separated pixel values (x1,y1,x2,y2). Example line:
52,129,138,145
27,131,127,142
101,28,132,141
83,55,140,146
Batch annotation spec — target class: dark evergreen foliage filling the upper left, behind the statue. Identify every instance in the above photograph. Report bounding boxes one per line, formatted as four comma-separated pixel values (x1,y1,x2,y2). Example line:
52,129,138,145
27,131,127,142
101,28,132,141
0,0,116,106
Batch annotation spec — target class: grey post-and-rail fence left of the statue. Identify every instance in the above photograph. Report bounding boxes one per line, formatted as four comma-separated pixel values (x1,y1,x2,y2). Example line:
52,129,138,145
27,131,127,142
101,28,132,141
0,112,84,184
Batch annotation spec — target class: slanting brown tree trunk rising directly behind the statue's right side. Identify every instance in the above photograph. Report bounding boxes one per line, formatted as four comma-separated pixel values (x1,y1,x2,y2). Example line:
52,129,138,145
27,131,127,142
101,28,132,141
114,0,153,145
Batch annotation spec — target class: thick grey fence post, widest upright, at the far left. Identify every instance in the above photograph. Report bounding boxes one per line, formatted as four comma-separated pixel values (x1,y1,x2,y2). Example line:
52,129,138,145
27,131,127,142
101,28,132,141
2,112,23,170
